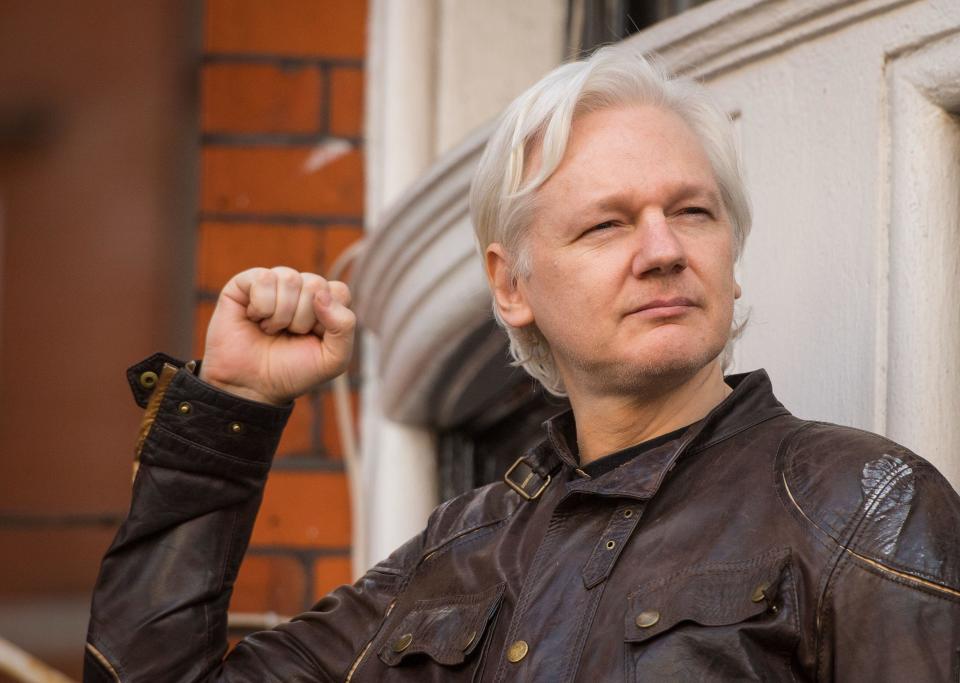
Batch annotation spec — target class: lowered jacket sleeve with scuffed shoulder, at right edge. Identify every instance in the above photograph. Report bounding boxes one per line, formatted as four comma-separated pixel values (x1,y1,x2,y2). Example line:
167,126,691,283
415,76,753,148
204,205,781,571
807,428,960,683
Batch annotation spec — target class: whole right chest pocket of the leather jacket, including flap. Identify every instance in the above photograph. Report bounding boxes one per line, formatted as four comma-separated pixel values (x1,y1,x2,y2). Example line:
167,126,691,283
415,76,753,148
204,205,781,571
625,549,799,681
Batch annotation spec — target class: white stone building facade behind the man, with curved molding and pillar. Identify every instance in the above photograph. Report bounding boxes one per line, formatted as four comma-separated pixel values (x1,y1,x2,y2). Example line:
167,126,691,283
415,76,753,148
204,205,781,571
353,0,960,572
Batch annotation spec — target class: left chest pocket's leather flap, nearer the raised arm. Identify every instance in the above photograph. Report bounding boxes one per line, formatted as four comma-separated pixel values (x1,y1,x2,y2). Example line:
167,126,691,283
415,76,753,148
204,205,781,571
378,583,505,666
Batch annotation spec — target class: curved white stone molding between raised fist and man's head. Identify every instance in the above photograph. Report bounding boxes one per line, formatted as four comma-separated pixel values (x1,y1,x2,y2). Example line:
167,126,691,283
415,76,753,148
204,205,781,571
353,122,491,425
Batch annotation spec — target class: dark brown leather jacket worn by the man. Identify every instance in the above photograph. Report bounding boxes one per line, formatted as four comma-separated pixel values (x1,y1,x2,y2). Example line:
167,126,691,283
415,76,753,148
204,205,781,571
85,358,960,683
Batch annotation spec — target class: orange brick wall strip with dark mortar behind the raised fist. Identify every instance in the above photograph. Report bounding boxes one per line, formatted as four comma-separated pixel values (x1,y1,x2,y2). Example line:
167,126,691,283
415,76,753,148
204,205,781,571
194,0,367,614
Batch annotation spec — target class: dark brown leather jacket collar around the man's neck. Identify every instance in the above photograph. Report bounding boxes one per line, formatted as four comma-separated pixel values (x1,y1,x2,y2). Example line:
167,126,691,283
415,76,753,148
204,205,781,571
533,370,789,499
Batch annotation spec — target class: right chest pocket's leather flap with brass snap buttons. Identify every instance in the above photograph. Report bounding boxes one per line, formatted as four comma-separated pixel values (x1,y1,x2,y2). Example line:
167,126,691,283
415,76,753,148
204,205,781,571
625,548,790,643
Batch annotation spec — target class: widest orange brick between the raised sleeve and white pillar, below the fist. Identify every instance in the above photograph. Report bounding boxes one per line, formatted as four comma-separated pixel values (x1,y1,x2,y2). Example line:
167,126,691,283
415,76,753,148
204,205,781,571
252,471,350,548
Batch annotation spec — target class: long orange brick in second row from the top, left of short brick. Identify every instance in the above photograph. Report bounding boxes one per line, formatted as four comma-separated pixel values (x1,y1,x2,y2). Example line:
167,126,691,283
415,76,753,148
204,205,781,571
201,64,322,133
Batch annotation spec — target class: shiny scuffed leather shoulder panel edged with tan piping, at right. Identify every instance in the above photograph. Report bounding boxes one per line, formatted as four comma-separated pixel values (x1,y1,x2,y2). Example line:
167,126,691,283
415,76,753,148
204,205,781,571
778,422,960,590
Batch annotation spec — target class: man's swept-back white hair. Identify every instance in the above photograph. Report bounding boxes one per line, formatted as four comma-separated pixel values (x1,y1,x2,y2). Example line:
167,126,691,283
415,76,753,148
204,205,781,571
470,45,751,396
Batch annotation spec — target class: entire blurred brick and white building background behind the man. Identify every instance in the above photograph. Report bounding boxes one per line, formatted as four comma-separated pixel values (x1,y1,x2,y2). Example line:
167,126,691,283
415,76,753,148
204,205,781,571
0,0,960,681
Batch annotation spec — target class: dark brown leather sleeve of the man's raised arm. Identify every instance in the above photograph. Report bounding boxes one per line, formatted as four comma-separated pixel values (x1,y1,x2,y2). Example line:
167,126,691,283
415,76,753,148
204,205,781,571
84,357,422,683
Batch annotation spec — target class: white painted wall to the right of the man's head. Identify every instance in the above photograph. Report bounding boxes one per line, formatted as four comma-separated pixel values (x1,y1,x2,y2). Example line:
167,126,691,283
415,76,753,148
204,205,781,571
652,1,960,485
